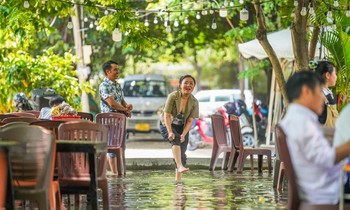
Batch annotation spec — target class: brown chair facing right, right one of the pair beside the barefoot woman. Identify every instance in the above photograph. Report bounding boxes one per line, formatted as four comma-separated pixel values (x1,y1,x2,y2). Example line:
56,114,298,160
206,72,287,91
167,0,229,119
228,115,272,173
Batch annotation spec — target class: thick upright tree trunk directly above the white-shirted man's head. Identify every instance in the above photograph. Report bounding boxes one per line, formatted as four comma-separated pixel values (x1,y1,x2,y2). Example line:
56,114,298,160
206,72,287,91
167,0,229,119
290,0,309,71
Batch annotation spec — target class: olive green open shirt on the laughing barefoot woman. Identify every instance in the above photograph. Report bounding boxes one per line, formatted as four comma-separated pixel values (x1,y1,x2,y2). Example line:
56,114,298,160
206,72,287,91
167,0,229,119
162,91,199,124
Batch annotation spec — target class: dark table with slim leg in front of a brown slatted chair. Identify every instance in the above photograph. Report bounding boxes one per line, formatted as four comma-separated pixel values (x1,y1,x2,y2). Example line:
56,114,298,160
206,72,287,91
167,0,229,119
56,140,107,210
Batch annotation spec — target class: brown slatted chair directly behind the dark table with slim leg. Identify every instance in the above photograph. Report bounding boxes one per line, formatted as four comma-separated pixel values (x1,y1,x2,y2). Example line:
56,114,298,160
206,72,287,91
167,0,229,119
57,120,109,210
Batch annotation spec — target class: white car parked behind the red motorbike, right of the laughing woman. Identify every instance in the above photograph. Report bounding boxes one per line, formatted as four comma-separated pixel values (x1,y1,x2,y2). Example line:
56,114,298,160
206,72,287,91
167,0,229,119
194,89,253,116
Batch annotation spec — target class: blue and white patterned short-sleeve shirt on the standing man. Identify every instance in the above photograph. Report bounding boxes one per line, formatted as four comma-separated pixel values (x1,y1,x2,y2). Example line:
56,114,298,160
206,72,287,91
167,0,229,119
100,77,124,113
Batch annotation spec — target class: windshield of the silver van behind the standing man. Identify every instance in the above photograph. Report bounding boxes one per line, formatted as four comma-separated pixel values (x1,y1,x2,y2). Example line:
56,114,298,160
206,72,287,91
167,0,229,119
123,80,167,97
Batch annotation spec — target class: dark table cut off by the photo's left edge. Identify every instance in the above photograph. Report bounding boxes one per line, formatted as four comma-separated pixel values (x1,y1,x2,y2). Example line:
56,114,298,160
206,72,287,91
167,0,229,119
0,140,17,209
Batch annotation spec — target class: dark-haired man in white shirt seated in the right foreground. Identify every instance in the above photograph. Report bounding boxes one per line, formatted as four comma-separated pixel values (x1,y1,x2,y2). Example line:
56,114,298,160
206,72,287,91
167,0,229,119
280,71,350,204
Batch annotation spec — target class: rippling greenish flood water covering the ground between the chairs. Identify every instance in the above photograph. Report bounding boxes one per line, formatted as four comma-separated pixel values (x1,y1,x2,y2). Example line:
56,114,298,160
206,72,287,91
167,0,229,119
104,170,287,209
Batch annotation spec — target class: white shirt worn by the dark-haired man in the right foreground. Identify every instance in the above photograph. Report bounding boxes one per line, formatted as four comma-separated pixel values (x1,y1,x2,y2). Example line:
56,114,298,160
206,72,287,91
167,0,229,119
280,103,342,204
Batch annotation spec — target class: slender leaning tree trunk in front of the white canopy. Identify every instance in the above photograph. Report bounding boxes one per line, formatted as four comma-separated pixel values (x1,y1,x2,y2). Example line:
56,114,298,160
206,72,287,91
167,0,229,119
254,0,288,107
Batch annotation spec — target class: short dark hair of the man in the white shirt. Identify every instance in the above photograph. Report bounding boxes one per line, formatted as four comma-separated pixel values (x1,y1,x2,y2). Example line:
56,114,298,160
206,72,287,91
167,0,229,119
286,70,324,102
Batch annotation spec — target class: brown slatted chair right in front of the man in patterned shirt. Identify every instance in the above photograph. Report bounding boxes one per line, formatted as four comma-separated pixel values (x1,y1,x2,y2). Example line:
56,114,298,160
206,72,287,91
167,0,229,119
96,112,126,175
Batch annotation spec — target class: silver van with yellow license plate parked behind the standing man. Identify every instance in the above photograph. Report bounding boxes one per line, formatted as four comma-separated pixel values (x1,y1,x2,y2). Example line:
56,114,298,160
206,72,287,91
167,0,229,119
122,74,168,133
